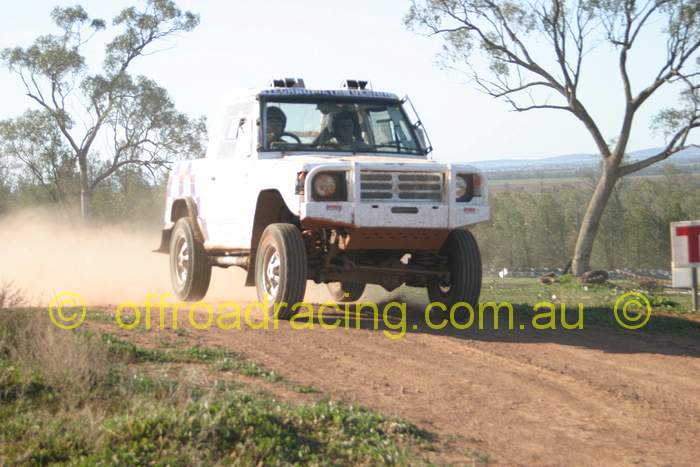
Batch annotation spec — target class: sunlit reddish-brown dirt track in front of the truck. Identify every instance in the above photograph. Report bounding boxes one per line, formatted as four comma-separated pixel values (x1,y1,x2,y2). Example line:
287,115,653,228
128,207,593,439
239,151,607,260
156,292,700,465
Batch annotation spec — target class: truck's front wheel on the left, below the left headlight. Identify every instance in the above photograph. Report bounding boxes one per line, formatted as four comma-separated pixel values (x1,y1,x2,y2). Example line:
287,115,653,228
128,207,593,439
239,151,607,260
255,223,306,319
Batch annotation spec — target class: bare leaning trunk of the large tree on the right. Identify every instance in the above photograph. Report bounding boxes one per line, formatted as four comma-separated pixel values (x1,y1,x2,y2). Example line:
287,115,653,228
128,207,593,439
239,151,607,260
571,162,617,276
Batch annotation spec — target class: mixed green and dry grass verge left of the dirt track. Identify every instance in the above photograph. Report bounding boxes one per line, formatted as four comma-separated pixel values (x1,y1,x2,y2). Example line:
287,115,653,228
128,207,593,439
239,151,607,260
0,310,433,466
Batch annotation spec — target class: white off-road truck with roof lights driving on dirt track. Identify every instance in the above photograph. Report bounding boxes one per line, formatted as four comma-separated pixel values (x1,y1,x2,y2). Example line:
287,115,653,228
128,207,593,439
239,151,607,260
158,79,489,317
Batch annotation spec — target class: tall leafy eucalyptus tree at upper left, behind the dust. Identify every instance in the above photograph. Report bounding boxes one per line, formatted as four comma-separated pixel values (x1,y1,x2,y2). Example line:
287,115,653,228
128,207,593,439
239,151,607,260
2,0,205,218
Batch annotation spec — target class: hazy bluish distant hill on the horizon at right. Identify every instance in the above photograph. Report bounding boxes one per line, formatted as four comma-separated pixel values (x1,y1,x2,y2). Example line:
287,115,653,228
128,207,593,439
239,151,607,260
472,147,700,173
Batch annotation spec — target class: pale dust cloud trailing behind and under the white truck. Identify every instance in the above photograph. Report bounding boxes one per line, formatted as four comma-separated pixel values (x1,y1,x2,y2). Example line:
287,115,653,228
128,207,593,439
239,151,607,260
0,209,255,306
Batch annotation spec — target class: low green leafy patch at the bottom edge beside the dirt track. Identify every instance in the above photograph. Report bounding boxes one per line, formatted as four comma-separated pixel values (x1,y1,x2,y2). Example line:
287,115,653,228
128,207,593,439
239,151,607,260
86,391,425,465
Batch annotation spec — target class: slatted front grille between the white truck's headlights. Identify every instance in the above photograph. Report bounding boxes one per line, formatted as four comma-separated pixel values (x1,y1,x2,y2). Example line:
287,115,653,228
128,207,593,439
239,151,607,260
360,171,444,202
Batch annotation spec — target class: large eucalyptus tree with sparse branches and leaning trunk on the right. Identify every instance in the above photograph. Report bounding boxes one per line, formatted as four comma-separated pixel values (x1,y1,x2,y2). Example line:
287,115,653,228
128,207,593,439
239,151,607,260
405,0,700,274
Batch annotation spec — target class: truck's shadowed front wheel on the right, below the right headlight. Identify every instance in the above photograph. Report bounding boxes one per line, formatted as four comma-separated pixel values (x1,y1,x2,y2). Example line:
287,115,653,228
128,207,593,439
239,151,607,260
428,230,481,310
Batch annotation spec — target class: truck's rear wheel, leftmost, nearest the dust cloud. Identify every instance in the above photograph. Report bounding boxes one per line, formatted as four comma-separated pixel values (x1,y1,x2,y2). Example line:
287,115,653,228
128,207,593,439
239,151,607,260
170,217,211,302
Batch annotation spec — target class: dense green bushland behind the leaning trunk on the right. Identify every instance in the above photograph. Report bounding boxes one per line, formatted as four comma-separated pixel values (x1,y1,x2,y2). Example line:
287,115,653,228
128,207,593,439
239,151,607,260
475,175,700,270
